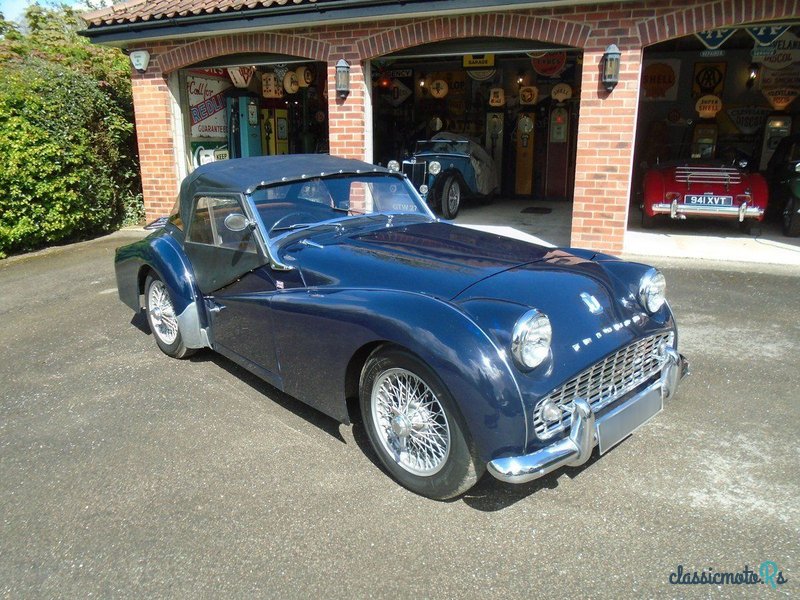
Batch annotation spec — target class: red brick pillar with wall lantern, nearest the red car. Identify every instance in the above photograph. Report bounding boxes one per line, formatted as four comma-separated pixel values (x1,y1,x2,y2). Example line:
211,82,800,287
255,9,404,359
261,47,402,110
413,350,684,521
572,43,642,254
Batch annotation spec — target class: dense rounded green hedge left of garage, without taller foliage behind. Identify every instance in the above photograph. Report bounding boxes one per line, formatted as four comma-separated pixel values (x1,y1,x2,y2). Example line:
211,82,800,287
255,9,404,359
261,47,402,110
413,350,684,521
0,57,135,258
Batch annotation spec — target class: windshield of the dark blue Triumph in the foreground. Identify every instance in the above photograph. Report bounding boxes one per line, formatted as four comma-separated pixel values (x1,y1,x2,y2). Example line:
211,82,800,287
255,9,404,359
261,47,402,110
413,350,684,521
251,174,432,238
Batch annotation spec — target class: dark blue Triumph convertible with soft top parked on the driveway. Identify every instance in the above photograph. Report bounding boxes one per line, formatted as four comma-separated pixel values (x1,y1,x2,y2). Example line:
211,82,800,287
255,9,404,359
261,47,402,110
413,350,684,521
116,155,686,499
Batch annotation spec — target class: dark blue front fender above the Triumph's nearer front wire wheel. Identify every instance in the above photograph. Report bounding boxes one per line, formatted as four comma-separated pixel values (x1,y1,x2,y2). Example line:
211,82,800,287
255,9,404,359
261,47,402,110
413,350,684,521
271,289,527,461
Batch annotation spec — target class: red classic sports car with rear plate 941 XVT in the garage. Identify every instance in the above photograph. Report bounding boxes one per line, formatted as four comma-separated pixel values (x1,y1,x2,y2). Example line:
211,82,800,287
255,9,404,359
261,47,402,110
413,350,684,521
641,159,769,231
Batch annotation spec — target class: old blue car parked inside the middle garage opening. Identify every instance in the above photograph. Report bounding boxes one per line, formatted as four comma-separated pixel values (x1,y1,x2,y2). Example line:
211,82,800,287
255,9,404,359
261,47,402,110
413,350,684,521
389,132,499,219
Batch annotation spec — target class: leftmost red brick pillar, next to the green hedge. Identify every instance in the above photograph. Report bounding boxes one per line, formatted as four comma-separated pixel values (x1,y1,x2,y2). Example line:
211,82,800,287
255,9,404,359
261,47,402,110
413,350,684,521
131,62,179,221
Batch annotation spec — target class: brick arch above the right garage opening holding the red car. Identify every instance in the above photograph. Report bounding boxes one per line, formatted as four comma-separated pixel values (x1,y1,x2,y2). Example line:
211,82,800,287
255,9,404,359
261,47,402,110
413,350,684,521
638,0,800,46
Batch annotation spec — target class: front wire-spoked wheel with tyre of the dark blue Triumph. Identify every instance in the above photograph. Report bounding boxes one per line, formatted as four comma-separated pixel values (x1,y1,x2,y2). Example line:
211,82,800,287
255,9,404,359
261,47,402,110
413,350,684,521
360,348,486,500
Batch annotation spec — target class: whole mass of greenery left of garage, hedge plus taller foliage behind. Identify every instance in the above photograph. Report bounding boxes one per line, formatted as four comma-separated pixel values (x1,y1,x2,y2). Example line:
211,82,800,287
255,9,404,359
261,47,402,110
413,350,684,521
0,4,143,258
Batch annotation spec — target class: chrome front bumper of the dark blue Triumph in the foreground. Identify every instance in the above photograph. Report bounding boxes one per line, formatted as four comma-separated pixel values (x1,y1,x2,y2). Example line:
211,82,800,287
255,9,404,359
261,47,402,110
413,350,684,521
487,350,689,483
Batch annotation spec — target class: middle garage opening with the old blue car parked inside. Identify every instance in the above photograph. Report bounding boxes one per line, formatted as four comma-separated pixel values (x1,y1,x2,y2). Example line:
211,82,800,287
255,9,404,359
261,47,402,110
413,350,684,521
371,38,582,244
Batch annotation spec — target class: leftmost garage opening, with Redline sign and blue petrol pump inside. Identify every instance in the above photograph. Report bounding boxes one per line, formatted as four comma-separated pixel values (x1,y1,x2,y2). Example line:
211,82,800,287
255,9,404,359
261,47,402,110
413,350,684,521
175,54,328,170
